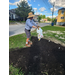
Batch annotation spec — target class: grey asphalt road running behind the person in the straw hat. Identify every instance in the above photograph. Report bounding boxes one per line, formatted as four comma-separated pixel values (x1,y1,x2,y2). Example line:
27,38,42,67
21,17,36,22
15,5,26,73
9,23,50,37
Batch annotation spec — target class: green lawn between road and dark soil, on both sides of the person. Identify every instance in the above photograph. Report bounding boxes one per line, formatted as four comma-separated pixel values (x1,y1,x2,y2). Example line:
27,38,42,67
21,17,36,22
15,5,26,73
9,26,65,49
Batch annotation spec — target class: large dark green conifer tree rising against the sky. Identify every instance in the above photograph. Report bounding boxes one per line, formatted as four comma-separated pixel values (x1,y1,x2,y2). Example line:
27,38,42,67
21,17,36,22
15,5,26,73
15,0,34,21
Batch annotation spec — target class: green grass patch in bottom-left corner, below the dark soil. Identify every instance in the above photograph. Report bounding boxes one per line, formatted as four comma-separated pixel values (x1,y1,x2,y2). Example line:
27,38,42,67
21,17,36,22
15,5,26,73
9,65,24,75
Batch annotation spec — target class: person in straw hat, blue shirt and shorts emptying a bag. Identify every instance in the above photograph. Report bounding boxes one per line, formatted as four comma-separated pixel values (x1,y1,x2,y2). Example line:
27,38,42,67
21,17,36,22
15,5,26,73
25,12,38,47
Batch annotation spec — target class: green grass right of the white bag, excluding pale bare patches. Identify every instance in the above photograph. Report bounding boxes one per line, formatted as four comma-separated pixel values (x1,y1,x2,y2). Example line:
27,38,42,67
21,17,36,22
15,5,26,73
42,26,65,43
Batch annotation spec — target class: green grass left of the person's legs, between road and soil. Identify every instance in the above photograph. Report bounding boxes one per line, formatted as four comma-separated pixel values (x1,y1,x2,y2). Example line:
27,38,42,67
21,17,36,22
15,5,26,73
9,33,26,51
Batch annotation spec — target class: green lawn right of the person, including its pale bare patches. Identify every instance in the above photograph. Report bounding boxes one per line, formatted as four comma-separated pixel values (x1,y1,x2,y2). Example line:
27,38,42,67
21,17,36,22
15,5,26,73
31,26,65,43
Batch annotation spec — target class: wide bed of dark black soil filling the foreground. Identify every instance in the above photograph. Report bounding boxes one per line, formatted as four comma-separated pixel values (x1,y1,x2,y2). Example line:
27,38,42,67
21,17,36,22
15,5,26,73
9,37,65,75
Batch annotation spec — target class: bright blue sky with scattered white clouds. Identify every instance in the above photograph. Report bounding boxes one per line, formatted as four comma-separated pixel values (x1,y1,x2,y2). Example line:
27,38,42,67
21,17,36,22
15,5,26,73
9,0,65,18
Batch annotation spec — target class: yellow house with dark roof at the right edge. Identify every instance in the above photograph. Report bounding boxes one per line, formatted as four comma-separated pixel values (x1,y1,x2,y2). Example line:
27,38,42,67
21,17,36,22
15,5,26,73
56,8,65,25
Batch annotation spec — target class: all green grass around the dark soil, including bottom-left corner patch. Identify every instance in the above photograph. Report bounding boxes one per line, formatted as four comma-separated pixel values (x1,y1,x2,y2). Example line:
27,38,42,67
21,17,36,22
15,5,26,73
9,26,65,75
